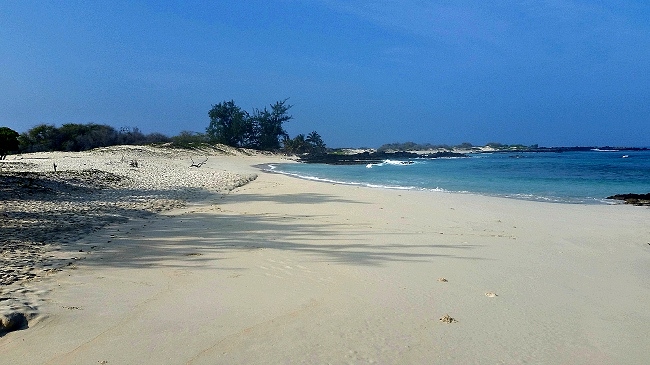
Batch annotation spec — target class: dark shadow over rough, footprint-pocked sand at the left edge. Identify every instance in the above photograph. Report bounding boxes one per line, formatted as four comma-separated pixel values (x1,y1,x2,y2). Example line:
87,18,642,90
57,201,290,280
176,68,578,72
0,170,210,288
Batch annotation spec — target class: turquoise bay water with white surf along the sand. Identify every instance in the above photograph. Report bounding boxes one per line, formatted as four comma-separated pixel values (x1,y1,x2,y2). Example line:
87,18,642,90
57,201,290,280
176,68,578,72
271,151,650,204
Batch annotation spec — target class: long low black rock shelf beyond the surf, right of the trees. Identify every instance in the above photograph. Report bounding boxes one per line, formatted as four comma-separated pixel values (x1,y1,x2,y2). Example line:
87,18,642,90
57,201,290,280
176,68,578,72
300,152,467,165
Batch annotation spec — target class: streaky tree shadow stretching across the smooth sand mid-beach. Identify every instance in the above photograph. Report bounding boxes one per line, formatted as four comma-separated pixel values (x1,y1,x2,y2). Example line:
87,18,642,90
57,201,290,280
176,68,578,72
74,193,481,267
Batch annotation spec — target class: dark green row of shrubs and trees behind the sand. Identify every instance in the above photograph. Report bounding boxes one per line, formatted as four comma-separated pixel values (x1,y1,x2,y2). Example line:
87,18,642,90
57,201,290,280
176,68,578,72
0,99,326,155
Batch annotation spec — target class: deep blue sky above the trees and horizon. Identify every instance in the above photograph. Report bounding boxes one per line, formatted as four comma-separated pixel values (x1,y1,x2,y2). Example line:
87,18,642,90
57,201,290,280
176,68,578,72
0,0,650,147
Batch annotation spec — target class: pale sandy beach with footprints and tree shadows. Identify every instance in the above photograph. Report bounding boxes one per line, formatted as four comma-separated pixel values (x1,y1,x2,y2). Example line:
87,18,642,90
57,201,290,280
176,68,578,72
0,147,650,364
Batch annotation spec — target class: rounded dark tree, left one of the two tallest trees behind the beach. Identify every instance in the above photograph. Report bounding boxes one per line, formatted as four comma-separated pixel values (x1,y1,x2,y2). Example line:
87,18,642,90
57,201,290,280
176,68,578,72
205,100,252,147
